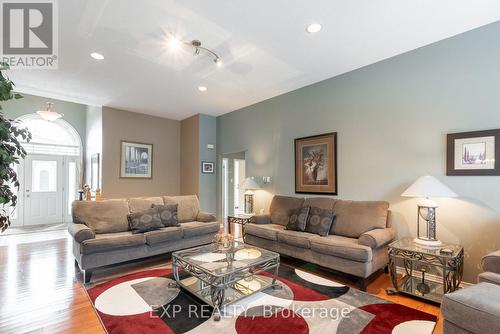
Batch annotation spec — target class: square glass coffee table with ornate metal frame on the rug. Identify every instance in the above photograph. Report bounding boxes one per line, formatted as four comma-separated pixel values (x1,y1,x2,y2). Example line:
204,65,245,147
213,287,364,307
172,242,281,321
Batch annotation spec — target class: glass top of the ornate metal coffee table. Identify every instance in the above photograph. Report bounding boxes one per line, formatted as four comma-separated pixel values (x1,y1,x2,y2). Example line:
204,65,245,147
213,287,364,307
173,241,279,276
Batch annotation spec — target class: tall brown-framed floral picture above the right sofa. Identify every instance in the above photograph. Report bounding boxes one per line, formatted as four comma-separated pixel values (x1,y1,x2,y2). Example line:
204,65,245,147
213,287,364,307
295,132,337,195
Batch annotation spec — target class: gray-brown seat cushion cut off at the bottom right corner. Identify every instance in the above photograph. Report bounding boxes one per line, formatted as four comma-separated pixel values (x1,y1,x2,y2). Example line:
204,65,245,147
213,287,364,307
441,283,500,334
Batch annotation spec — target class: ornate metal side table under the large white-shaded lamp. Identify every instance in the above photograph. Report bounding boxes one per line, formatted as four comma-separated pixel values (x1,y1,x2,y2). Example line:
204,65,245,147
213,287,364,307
389,238,464,303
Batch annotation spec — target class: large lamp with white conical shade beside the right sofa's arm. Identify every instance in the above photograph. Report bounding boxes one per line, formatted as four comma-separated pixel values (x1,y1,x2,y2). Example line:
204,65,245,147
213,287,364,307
401,175,458,247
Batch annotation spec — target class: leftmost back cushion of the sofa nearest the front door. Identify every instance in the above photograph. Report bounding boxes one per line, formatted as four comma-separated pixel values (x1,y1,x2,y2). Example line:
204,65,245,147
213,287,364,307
72,199,129,234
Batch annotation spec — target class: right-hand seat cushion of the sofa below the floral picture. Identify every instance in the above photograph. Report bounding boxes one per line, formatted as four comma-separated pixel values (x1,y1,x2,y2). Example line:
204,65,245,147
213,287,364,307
310,235,373,262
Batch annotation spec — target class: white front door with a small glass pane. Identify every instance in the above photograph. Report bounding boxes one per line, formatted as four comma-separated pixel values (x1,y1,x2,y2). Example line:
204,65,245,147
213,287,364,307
24,155,64,225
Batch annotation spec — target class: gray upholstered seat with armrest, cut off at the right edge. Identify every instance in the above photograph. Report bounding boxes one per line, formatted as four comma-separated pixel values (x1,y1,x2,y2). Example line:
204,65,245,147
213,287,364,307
441,251,500,334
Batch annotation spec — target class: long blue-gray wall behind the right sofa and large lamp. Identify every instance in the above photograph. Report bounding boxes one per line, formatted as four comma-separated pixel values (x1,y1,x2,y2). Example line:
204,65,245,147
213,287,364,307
217,23,500,282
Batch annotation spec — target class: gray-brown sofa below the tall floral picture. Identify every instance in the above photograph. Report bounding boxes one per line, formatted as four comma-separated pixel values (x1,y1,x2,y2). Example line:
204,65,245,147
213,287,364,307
244,196,395,290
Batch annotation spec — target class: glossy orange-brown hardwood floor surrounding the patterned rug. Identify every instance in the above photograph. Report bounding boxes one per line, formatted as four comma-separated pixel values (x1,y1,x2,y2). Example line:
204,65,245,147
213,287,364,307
0,231,442,334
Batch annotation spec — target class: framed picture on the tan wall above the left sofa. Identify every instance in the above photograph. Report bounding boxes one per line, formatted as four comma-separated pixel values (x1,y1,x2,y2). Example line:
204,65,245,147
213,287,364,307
120,140,153,179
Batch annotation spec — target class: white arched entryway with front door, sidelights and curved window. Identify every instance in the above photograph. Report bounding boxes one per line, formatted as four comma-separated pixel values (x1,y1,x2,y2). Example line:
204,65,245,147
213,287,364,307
12,114,83,226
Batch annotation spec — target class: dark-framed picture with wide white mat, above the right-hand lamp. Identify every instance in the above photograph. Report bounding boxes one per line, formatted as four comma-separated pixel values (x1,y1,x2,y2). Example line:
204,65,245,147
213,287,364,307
446,129,500,175
